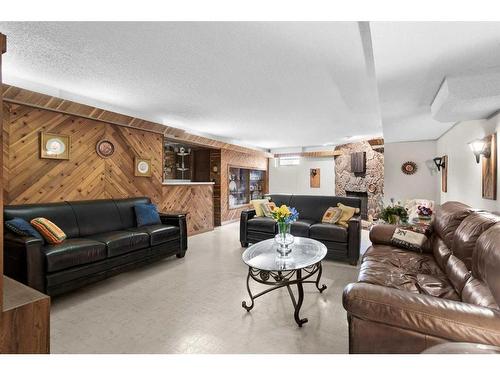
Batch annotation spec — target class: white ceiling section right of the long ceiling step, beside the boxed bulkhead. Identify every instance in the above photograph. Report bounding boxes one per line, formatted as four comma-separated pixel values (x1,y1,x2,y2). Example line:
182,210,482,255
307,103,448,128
370,22,500,142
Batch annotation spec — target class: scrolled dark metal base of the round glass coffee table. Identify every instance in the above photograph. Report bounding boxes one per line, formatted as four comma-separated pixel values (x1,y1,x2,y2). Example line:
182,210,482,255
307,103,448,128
241,262,326,327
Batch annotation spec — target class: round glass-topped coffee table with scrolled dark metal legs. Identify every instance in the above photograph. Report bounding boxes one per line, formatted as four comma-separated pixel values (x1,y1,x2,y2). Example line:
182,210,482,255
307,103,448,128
241,237,326,327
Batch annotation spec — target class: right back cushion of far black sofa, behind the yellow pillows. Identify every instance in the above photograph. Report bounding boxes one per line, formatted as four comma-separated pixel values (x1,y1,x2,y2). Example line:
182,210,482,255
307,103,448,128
290,195,361,223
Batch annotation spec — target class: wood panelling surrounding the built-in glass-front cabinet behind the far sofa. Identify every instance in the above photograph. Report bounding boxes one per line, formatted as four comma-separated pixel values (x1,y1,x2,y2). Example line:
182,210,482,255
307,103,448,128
220,149,269,223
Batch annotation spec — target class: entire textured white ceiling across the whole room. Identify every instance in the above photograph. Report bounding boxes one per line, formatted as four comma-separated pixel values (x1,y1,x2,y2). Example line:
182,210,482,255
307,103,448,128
0,22,500,148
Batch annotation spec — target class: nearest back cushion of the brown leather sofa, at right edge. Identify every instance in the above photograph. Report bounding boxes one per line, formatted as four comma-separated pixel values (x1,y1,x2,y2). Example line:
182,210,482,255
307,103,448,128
464,223,500,306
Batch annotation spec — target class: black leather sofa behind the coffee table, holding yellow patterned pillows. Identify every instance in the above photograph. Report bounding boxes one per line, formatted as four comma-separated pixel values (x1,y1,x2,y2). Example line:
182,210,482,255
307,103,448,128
240,194,361,265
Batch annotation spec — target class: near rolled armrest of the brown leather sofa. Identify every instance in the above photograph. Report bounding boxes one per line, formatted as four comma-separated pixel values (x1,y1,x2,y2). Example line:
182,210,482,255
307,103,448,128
343,283,500,346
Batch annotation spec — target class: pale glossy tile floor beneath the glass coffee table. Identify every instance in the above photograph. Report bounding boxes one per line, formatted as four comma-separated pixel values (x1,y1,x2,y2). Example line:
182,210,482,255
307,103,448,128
51,223,369,353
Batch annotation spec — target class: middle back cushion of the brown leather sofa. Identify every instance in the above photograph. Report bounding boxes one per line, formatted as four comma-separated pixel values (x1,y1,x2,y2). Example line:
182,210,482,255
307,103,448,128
451,212,500,270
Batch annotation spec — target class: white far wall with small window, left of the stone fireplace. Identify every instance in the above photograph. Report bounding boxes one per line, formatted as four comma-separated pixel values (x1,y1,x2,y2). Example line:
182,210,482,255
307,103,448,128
269,158,335,195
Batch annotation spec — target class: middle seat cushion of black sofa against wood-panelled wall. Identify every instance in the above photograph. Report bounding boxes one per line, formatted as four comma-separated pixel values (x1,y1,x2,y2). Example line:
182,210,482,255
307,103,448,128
86,230,149,257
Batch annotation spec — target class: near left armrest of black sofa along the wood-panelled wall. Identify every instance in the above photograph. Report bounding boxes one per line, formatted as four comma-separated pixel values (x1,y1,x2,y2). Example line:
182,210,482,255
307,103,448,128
4,231,45,292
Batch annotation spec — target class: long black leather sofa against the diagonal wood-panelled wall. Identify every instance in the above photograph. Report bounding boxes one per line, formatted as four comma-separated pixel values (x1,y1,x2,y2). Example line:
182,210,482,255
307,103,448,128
4,197,187,296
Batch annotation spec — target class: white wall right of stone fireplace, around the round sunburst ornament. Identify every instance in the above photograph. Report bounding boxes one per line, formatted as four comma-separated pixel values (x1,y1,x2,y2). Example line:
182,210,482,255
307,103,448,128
384,141,440,204
